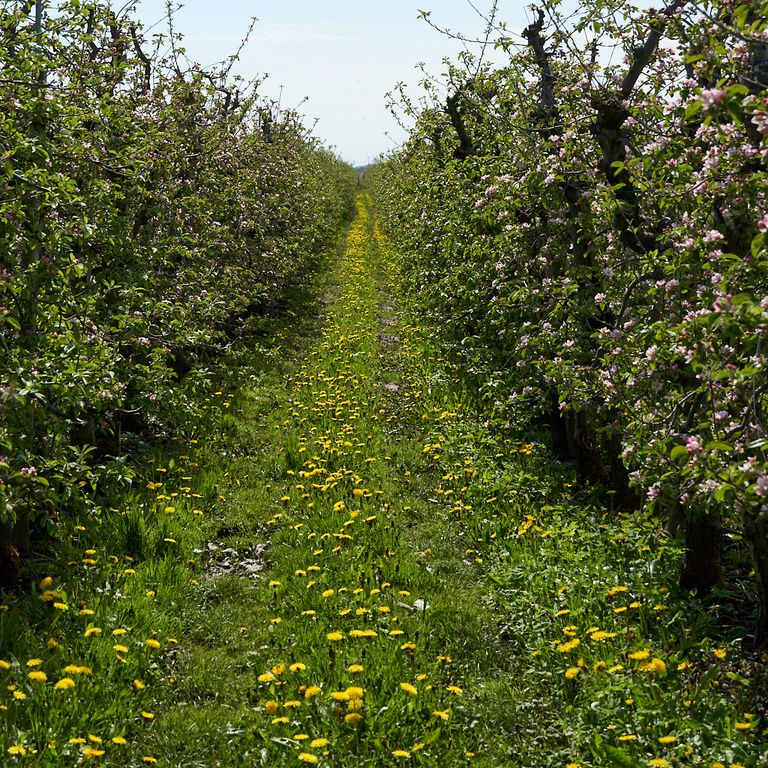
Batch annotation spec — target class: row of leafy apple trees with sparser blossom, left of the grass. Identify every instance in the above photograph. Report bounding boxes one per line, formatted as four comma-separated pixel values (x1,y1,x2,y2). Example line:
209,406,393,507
0,0,352,581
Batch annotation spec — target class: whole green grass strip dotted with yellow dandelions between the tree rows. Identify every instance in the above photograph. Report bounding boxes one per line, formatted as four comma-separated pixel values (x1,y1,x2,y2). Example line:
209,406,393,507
0,198,768,768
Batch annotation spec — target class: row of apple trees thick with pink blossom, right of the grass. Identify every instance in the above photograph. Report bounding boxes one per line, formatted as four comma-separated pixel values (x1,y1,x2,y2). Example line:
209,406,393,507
375,0,768,642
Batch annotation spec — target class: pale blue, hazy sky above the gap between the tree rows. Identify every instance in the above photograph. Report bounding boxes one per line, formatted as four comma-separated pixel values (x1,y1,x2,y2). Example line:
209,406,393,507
129,0,529,165
